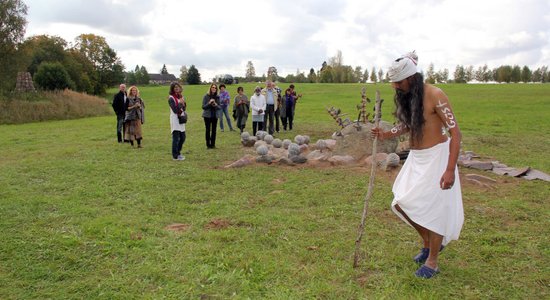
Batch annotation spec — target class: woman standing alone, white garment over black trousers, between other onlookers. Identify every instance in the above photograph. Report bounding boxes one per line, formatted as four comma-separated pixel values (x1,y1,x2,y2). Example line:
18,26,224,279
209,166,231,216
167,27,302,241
168,82,187,160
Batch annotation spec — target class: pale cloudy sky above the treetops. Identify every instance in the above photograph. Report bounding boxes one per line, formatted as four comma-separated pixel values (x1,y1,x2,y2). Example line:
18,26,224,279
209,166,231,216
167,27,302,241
24,0,550,81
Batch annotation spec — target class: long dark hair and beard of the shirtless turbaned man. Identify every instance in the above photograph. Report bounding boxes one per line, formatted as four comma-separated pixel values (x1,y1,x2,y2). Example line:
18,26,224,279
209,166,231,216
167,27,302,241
394,73,426,143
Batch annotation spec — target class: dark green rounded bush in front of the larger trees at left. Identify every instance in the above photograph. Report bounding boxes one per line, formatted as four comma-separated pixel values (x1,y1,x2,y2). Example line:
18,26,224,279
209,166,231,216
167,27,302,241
33,62,72,90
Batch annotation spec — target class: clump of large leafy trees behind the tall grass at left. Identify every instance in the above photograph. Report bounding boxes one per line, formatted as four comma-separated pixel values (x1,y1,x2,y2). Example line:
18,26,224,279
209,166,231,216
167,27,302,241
0,0,124,95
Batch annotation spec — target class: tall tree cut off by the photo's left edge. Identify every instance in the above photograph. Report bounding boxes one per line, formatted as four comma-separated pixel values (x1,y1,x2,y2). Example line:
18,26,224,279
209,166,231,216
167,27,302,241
0,0,27,90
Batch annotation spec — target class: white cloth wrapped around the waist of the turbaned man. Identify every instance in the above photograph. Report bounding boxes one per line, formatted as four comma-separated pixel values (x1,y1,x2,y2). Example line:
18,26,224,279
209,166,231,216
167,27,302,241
391,140,464,245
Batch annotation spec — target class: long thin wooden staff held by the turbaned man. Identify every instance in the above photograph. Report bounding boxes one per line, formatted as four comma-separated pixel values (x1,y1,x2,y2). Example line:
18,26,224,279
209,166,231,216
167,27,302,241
353,90,382,268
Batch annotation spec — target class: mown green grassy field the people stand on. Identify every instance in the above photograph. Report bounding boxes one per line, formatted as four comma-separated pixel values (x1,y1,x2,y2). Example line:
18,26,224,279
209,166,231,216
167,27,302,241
0,84,550,299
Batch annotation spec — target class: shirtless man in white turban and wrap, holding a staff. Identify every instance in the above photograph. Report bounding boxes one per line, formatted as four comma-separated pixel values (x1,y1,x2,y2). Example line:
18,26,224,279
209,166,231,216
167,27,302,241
372,52,464,278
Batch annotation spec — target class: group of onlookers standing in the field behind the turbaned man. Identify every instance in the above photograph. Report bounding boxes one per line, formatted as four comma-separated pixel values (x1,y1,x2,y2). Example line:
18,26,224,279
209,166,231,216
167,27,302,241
112,81,302,160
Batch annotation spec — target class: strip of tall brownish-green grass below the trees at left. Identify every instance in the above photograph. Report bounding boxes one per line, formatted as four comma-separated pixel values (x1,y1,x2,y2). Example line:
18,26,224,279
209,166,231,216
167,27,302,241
0,90,112,124
